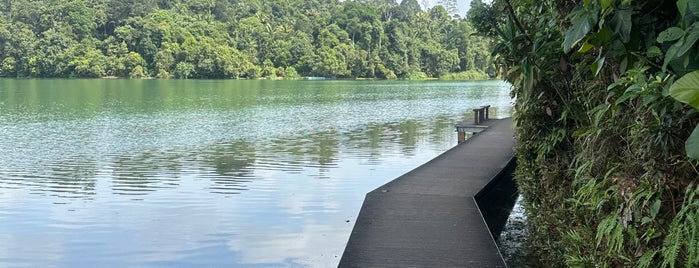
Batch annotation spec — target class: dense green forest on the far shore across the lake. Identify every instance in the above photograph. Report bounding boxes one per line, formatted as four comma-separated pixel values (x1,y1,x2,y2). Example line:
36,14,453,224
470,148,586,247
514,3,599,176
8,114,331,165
0,0,495,79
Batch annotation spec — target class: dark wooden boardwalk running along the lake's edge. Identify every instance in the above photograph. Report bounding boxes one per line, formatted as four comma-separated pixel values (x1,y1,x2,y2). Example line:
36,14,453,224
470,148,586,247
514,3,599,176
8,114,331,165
339,119,514,267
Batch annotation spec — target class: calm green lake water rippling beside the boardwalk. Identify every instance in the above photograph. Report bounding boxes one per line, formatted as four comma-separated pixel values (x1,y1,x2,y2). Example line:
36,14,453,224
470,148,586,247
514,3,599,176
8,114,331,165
0,80,510,267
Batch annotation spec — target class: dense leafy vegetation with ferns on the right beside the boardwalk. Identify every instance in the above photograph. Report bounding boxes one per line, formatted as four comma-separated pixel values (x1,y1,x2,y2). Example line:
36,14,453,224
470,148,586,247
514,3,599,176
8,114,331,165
468,0,699,267
